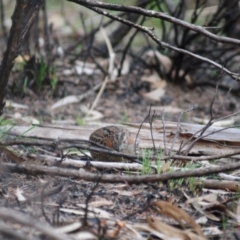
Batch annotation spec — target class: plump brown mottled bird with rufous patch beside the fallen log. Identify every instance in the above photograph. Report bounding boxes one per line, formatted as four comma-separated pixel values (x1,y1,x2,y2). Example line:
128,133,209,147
89,126,135,162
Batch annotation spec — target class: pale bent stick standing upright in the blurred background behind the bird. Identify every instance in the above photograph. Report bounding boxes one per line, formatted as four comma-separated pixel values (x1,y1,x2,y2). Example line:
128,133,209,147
86,28,115,117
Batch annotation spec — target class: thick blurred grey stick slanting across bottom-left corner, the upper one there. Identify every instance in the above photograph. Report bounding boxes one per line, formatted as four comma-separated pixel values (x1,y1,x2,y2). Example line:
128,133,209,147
0,207,73,240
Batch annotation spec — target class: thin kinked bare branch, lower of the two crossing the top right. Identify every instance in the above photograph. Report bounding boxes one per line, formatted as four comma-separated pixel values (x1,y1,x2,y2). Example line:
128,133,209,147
74,0,240,80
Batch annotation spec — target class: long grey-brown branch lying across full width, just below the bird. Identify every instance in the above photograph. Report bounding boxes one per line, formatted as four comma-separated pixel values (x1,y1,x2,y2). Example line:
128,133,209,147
3,162,240,185
